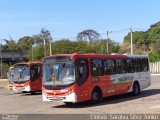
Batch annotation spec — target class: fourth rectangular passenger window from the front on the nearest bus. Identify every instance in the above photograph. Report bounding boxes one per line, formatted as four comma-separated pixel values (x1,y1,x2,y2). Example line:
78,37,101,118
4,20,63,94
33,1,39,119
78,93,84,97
126,58,135,73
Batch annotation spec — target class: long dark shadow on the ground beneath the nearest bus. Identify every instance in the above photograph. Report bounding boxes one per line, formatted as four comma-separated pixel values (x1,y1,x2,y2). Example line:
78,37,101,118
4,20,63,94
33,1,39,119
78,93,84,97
52,89,160,108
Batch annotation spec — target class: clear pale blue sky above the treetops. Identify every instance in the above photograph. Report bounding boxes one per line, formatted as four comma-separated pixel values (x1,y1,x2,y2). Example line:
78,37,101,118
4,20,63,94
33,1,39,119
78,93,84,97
0,0,160,43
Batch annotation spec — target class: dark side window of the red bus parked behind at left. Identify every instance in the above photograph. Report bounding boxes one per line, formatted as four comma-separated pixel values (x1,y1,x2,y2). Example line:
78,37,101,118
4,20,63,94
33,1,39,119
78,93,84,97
31,65,40,81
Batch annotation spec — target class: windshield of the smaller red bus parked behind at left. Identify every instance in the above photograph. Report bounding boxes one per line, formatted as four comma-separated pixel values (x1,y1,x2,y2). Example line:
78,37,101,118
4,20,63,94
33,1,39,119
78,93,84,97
14,65,30,81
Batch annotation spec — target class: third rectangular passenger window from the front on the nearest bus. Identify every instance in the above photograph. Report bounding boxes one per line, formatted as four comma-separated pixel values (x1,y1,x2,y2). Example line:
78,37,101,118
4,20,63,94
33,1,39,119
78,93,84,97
115,59,126,74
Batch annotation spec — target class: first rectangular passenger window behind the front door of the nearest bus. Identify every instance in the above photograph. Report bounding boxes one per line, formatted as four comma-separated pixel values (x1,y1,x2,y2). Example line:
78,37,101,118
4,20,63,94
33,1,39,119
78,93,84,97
91,59,104,76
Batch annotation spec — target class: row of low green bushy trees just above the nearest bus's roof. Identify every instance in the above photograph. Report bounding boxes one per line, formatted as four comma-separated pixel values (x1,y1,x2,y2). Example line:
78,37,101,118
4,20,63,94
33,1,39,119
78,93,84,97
28,39,120,60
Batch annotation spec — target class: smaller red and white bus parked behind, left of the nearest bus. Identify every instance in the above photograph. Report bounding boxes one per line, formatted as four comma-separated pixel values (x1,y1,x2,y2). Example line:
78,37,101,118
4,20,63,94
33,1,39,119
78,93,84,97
13,62,42,93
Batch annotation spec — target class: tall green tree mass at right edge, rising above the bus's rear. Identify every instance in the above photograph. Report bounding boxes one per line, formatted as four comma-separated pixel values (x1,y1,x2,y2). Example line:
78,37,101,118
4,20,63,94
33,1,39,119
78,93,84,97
122,22,160,61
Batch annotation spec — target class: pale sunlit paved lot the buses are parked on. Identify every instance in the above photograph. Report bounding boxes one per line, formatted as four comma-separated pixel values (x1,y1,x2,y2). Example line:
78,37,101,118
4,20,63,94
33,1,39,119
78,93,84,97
0,76,160,114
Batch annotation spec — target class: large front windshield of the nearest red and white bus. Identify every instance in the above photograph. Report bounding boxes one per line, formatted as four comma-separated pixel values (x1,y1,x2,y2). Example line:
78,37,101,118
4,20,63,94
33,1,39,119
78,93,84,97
43,58,75,86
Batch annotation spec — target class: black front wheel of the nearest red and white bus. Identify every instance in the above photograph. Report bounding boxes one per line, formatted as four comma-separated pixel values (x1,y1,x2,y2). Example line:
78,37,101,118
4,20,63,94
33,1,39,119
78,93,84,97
91,89,102,104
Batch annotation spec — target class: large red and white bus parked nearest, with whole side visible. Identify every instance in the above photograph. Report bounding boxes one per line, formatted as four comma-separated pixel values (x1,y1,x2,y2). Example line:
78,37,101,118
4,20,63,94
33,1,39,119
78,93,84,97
42,53,151,103
